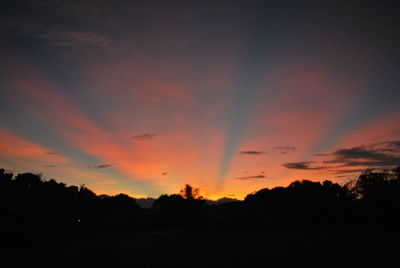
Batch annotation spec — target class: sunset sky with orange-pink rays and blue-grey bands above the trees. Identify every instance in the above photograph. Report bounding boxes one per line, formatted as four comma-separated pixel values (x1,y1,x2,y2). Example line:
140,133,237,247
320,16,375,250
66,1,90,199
0,0,400,199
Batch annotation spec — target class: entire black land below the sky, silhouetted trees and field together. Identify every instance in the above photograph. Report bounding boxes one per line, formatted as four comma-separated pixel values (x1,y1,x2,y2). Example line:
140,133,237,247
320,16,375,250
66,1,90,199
0,167,400,268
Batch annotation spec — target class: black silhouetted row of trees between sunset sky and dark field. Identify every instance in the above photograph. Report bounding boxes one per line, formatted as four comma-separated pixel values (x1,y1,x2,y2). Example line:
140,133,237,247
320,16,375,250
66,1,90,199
0,166,400,231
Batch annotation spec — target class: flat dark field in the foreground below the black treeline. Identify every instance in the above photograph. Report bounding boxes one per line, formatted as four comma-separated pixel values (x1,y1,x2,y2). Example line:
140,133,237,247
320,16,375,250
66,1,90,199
1,229,400,267
